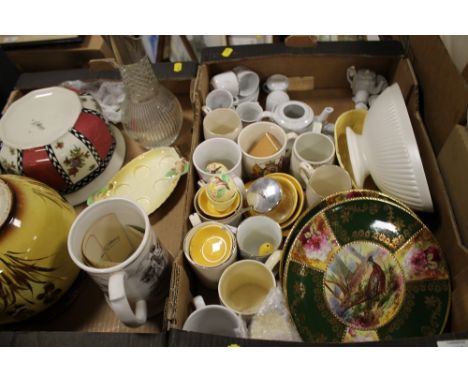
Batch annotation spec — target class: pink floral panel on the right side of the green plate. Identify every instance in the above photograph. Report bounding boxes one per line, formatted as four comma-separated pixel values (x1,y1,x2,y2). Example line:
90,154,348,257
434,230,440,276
396,229,449,281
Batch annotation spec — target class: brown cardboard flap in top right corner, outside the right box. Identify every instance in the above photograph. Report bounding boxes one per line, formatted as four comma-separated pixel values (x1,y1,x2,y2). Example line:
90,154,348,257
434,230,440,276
410,36,468,155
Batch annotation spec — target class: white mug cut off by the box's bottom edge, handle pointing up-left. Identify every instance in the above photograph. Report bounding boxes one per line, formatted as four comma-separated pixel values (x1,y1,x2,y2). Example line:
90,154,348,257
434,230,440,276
182,296,247,338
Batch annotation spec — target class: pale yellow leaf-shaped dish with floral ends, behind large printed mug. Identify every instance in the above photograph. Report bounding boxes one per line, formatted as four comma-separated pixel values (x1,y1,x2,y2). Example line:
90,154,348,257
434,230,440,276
88,147,188,215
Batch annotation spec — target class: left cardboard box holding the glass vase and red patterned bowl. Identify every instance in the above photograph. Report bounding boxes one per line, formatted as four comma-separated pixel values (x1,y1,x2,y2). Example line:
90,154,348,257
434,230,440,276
0,63,198,346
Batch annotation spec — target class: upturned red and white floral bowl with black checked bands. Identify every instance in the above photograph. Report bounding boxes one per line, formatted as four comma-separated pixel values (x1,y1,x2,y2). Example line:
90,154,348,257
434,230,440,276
0,87,115,194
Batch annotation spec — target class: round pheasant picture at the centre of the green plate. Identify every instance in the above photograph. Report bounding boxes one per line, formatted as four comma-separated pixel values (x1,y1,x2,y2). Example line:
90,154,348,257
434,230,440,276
323,241,405,330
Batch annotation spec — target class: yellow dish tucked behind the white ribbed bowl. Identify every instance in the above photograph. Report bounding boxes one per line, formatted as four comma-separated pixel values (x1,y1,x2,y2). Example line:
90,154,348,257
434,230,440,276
335,109,378,190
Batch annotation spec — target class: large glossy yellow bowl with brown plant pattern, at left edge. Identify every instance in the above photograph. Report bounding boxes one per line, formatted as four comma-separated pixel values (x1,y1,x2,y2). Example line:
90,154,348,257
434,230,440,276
0,175,79,324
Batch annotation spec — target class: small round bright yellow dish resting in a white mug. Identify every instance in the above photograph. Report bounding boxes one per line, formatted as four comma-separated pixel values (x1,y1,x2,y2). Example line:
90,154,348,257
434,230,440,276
189,224,233,267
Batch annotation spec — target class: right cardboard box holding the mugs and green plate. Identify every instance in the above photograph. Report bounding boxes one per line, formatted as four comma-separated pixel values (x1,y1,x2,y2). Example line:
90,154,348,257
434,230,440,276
166,41,468,346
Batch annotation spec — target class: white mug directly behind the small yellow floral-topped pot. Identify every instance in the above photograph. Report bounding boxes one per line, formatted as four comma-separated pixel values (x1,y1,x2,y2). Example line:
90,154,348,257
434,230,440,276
192,138,242,182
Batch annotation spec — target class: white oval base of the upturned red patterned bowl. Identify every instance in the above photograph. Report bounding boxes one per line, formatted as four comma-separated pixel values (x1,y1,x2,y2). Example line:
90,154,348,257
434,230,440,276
0,87,82,150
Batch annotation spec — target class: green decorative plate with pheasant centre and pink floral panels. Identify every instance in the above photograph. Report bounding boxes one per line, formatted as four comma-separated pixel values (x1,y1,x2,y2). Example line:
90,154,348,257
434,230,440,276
282,197,450,342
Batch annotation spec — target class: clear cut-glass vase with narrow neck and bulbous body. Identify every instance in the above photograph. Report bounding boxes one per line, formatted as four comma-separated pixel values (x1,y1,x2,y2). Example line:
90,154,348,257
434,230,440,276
119,56,183,149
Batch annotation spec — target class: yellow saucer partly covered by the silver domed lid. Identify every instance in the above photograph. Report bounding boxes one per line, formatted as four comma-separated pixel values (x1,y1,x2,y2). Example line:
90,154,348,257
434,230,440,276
246,173,298,225
